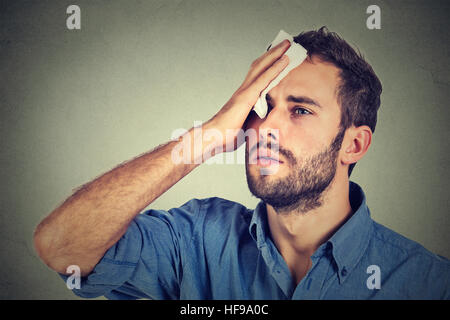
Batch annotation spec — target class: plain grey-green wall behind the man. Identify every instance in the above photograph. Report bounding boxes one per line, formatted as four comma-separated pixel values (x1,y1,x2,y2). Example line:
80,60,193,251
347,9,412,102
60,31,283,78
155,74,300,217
0,0,450,299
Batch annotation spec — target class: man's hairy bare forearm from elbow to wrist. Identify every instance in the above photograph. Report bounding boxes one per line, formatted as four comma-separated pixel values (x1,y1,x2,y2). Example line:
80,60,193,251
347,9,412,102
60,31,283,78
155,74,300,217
34,125,209,274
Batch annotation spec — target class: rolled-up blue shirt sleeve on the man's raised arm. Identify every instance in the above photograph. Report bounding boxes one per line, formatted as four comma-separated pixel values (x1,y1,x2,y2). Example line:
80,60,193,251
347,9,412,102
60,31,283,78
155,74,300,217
60,199,201,299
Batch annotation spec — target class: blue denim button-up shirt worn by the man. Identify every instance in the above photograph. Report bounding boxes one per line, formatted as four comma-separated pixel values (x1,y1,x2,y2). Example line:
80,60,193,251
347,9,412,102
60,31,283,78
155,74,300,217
62,182,450,299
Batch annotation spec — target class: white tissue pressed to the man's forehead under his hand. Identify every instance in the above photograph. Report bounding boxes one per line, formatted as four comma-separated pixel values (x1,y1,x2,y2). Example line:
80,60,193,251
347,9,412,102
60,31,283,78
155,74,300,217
253,30,307,119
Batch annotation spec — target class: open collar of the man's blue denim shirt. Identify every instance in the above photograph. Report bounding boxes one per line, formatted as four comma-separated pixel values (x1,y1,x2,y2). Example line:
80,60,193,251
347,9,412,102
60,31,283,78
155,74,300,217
249,181,372,283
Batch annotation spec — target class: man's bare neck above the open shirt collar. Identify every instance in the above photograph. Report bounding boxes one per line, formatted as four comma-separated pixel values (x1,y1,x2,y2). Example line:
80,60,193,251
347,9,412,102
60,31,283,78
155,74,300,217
266,173,352,271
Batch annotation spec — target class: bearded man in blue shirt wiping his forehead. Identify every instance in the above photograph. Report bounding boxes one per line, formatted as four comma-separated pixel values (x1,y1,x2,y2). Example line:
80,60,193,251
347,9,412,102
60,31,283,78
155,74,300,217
34,28,450,299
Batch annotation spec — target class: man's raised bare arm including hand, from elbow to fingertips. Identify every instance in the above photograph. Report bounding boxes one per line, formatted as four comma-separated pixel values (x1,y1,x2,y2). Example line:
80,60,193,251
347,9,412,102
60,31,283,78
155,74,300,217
34,42,289,275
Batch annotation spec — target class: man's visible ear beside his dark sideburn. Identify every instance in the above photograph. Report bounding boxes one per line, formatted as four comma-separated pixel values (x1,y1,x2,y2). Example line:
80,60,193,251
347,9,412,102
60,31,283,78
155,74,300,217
341,126,372,165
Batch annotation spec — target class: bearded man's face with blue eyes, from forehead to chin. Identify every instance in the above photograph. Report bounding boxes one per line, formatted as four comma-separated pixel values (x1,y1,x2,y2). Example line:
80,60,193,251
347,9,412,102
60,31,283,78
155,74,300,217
246,57,344,212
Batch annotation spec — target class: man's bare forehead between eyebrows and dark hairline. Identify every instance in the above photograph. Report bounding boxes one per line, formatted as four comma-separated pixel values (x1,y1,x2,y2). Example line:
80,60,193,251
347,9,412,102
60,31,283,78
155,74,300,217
279,56,340,106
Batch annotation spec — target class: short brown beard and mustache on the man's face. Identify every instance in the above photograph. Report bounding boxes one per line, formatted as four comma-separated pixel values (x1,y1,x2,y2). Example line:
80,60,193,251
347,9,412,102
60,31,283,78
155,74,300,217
245,128,345,214
